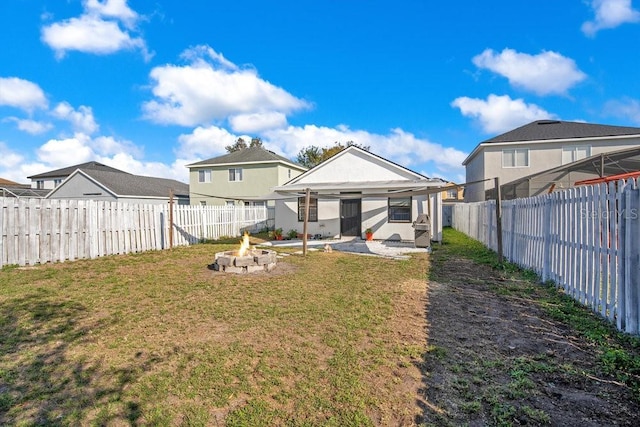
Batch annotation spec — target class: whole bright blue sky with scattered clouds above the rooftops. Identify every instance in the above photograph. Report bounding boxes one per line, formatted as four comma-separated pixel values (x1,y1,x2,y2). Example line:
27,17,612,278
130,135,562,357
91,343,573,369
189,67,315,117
0,0,640,183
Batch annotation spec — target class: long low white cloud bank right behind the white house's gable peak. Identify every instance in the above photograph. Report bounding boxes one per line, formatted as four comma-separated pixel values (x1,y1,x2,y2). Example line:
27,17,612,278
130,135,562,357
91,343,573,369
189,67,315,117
264,125,467,174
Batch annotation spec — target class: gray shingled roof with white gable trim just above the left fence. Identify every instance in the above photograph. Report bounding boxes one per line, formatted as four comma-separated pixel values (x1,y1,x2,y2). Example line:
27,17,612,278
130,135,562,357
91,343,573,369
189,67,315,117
49,169,189,198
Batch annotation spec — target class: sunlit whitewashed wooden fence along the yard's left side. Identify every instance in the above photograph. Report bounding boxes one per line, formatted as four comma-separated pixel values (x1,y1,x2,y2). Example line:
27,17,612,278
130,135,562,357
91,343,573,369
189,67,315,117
0,197,268,268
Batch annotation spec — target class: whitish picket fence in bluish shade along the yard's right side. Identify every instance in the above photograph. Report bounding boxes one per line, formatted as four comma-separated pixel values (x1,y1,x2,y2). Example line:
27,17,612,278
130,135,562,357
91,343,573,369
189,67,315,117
453,180,640,335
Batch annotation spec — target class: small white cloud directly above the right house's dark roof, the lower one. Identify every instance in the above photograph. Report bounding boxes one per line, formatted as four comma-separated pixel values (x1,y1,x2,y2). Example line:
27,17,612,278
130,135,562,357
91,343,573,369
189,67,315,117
451,95,556,133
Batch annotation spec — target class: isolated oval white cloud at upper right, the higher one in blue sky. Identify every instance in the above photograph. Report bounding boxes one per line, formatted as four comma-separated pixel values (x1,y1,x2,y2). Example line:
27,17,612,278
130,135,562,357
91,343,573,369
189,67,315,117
473,49,586,95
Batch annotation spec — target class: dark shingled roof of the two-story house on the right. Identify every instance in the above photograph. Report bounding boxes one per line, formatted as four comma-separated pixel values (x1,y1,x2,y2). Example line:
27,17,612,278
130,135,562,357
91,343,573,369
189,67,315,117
462,120,640,165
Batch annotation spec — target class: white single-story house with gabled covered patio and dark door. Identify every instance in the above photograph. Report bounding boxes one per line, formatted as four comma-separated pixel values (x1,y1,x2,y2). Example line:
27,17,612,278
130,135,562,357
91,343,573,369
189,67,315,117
273,145,444,241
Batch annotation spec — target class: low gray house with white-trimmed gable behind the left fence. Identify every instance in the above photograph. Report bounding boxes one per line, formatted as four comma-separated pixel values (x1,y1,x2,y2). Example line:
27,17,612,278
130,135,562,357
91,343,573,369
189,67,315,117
47,169,189,205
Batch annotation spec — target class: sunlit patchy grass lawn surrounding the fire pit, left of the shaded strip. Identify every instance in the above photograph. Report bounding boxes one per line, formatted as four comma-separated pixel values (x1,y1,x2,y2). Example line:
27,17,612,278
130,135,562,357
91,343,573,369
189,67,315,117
0,244,427,426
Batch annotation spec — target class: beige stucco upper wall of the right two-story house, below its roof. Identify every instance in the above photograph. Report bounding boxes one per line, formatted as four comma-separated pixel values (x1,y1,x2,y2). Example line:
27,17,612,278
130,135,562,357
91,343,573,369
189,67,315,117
464,138,640,202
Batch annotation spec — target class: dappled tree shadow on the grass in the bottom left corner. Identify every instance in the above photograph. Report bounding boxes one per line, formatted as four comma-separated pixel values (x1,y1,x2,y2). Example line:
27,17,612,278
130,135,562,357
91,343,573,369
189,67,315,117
0,291,154,425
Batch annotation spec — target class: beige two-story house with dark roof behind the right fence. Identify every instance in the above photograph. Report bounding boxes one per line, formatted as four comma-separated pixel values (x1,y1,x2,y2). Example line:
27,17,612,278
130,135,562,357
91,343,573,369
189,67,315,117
462,120,640,202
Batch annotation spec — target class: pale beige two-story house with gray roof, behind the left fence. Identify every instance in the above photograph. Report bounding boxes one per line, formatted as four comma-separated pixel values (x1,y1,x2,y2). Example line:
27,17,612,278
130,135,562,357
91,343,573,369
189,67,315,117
187,147,307,205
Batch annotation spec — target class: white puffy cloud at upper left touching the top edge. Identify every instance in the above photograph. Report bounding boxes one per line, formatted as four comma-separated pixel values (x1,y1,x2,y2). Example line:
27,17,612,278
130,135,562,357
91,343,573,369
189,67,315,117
41,0,152,60
